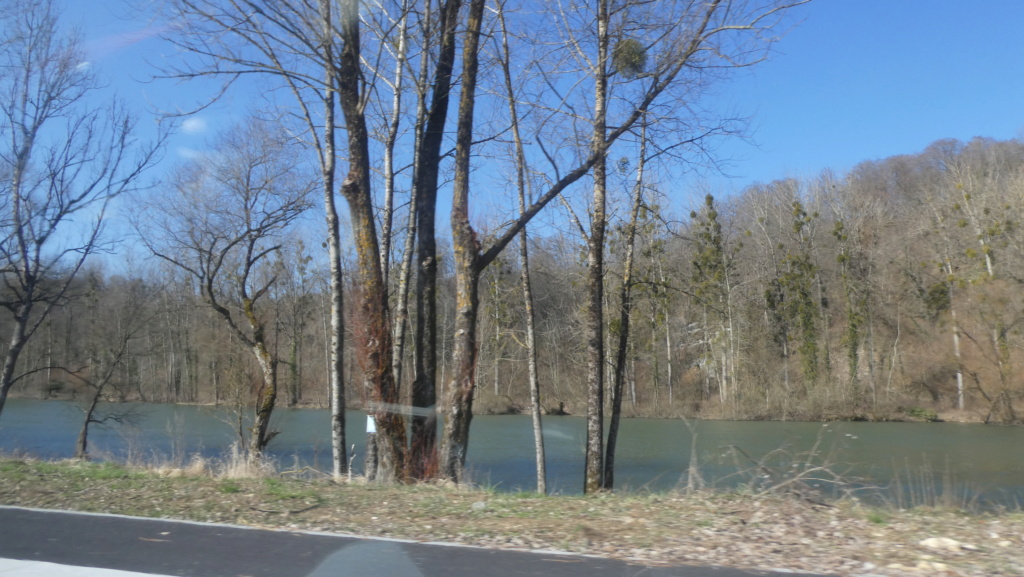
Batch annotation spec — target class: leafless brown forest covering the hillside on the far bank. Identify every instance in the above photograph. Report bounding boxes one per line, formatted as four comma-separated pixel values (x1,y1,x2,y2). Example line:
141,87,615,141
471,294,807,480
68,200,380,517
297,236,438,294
9,138,1024,422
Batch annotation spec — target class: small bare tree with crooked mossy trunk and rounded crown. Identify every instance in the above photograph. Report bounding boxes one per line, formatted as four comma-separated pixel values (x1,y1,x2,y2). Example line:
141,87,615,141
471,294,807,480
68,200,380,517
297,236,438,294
138,120,316,456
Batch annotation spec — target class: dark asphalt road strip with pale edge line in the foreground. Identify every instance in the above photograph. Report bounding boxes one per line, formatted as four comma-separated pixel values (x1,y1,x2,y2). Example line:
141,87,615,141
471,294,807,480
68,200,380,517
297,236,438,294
0,507,823,577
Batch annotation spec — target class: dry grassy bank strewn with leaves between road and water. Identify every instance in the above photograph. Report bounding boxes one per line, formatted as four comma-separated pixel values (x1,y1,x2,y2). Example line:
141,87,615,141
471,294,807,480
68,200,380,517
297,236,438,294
0,458,1024,576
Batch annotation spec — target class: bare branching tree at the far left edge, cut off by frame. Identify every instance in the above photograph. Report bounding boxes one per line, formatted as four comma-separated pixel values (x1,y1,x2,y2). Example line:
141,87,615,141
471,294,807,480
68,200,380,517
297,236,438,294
0,0,159,420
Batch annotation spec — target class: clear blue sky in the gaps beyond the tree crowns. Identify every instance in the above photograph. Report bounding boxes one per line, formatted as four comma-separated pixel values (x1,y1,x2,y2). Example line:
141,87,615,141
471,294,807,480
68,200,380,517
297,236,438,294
66,0,1024,196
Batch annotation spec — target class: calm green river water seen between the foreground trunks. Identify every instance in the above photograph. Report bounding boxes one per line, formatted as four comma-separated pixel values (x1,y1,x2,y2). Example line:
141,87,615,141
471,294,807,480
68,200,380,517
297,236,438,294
0,400,1024,506
